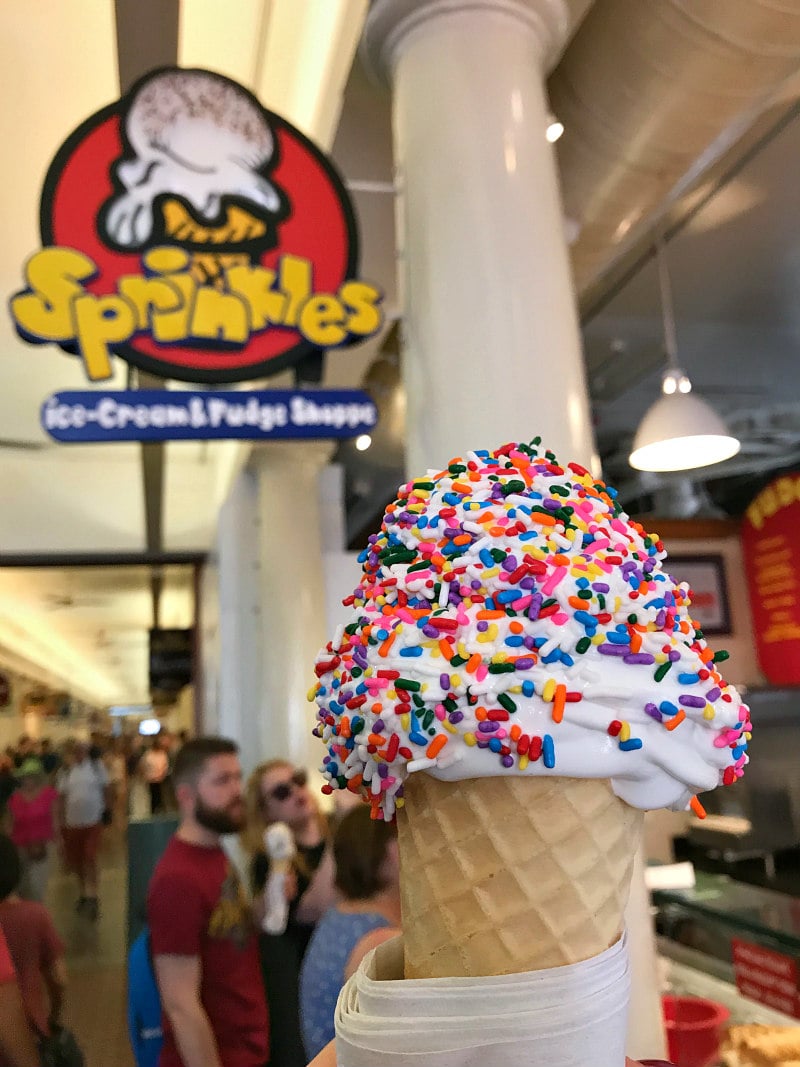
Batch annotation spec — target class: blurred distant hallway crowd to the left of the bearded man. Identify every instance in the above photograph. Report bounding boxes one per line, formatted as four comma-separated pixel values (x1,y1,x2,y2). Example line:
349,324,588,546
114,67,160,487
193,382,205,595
0,732,186,1067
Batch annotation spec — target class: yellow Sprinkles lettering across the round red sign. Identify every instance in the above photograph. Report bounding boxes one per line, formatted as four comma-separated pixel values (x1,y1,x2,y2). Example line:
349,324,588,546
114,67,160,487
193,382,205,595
11,246,382,381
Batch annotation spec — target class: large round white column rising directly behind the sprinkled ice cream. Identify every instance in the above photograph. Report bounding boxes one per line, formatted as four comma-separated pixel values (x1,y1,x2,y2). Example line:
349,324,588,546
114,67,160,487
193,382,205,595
365,0,594,474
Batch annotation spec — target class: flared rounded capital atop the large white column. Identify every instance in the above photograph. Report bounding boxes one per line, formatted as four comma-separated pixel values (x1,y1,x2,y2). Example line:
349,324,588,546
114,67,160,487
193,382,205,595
362,0,572,81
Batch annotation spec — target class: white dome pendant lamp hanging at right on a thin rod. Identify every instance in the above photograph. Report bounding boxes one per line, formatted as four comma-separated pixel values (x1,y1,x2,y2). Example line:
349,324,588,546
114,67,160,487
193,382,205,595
628,241,740,471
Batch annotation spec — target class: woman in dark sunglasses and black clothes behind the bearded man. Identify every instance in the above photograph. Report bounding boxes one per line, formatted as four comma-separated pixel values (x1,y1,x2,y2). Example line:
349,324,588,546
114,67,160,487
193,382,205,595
242,760,335,1067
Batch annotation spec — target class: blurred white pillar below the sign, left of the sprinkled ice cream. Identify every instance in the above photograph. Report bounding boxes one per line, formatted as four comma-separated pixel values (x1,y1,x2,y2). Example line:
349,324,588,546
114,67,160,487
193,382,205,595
208,442,342,774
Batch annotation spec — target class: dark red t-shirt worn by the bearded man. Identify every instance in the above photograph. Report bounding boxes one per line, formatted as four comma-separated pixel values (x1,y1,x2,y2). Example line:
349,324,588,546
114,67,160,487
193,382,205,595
147,837,269,1067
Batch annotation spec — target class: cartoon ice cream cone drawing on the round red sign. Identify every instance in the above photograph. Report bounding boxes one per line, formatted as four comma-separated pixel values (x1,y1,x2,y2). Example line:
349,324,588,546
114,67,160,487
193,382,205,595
100,70,286,281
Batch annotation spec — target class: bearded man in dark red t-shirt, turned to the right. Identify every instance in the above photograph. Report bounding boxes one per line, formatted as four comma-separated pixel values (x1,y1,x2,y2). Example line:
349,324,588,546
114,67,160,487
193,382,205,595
147,737,269,1067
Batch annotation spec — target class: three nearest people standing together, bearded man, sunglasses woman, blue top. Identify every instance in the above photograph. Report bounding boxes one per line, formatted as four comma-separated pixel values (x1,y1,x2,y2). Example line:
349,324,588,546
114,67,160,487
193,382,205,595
142,737,400,1067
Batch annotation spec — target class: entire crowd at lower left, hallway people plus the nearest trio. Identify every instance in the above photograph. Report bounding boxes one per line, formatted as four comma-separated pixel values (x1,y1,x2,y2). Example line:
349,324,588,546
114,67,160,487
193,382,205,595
0,733,400,1067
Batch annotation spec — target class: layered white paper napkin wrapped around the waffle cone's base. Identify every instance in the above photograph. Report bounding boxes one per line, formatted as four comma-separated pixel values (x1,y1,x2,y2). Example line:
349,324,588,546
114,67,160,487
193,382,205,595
336,938,630,1067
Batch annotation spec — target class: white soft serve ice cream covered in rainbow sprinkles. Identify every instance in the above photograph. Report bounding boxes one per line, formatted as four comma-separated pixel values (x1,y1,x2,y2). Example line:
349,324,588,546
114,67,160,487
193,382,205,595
309,441,751,818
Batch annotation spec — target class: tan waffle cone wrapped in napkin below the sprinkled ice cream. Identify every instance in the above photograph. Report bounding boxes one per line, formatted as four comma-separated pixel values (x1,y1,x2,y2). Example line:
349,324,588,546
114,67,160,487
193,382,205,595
398,774,642,978
